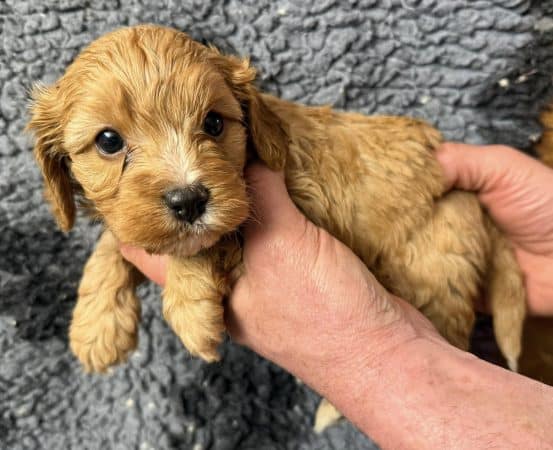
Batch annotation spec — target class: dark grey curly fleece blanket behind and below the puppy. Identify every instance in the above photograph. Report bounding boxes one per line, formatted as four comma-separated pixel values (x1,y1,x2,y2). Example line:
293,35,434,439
0,0,553,450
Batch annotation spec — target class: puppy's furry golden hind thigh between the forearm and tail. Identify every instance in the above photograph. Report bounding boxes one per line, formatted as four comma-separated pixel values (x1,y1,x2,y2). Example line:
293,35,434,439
376,192,491,350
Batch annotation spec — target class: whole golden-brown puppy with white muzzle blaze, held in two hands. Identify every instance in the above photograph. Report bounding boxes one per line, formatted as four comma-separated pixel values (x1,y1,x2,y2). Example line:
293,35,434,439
29,25,525,384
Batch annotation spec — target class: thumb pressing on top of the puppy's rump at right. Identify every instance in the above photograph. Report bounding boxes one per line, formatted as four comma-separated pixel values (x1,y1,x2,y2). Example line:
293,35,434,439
436,142,528,192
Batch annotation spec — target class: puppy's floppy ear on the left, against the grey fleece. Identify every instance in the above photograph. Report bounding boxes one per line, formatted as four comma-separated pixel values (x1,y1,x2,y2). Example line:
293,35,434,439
27,86,75,231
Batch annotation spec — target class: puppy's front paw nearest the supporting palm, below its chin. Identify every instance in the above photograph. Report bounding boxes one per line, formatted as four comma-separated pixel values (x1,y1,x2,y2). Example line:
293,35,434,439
163,293,225,362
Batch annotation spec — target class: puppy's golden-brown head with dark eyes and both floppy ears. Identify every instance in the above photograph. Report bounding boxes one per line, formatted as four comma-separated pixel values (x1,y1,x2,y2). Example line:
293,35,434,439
29,26,287,256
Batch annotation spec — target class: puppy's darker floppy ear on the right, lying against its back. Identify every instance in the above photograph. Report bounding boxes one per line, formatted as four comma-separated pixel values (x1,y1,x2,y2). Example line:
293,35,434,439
215,55,288,170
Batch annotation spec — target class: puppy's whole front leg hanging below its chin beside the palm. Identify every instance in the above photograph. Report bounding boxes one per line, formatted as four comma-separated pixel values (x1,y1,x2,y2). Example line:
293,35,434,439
163,252,229,362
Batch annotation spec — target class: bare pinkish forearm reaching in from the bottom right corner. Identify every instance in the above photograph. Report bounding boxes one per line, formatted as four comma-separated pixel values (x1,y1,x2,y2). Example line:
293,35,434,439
312,330,553,449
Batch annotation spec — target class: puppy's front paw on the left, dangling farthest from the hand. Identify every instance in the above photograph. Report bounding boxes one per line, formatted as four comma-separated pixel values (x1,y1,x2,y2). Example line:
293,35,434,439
69,290,140,373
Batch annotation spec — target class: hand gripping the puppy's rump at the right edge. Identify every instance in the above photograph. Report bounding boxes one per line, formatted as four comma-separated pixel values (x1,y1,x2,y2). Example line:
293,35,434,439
437,143,553,315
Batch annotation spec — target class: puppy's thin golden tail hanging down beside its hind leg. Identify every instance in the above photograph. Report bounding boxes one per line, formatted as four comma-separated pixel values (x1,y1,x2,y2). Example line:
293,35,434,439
487,218,526,372
